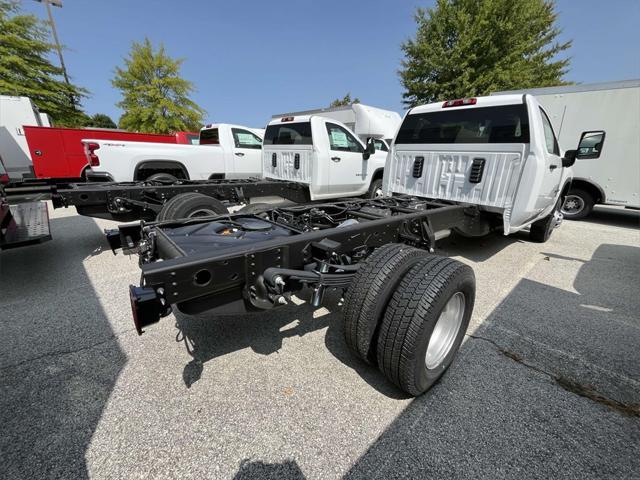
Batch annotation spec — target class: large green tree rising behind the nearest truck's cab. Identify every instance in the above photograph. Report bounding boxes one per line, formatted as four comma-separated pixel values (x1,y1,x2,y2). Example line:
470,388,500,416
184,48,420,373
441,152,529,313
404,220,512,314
399,0,571,106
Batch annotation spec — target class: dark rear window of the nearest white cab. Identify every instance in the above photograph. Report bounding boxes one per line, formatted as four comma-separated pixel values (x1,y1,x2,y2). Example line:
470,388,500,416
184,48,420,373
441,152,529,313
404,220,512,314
395,104,529,144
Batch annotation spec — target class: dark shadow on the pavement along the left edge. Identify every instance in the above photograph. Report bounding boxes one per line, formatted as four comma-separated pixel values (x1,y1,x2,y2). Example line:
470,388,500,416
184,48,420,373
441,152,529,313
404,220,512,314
0,216,127,479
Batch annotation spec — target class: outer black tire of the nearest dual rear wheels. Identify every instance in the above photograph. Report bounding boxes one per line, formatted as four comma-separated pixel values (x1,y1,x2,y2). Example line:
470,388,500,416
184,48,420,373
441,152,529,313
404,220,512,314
377,255,476,396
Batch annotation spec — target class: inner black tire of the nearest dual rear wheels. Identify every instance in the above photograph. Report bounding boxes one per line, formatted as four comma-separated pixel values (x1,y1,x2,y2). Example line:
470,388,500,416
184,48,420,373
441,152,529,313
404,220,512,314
343,243,429,364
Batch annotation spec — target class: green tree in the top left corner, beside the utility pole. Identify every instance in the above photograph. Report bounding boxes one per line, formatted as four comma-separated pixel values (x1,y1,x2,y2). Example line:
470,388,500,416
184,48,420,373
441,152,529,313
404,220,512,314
0,0,87,126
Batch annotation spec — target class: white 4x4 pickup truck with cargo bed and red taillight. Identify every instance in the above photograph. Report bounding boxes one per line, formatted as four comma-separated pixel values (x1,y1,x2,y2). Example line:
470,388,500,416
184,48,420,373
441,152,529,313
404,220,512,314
82,123,262,182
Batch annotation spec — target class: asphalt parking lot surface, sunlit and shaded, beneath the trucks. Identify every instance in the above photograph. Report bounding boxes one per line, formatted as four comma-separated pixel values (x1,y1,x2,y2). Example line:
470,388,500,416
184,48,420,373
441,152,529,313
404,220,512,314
0,204,640,479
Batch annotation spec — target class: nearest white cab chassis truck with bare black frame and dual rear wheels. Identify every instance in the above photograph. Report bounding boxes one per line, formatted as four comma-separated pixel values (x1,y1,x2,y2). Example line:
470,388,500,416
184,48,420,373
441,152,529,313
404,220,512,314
107,95,575,395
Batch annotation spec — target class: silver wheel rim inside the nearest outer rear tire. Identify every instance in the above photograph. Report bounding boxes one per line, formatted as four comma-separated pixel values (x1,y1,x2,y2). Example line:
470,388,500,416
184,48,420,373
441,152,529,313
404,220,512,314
424,292,466,370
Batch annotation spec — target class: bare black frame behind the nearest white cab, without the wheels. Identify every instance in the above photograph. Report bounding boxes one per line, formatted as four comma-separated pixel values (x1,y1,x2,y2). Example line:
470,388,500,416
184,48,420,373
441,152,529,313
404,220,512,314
106,196,480,333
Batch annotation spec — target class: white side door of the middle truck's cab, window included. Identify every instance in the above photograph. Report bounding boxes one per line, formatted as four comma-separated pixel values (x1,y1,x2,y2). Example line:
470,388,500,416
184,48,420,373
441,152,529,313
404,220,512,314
326,122,368,196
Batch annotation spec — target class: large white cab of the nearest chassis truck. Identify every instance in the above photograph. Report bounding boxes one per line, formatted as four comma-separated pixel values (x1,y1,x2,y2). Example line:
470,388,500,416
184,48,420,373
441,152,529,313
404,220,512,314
384,95,578,235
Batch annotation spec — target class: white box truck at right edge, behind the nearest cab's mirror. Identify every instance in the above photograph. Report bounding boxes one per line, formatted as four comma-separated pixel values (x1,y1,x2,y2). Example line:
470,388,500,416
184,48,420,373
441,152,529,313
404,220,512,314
497,80,640,220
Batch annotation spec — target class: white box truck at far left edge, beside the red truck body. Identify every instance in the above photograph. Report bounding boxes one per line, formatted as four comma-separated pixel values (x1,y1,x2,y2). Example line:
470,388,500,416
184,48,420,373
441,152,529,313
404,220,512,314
0,95,48,182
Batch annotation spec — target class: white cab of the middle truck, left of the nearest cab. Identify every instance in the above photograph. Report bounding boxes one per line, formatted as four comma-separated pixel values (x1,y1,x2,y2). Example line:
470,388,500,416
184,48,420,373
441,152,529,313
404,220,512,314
262,115,388,200
